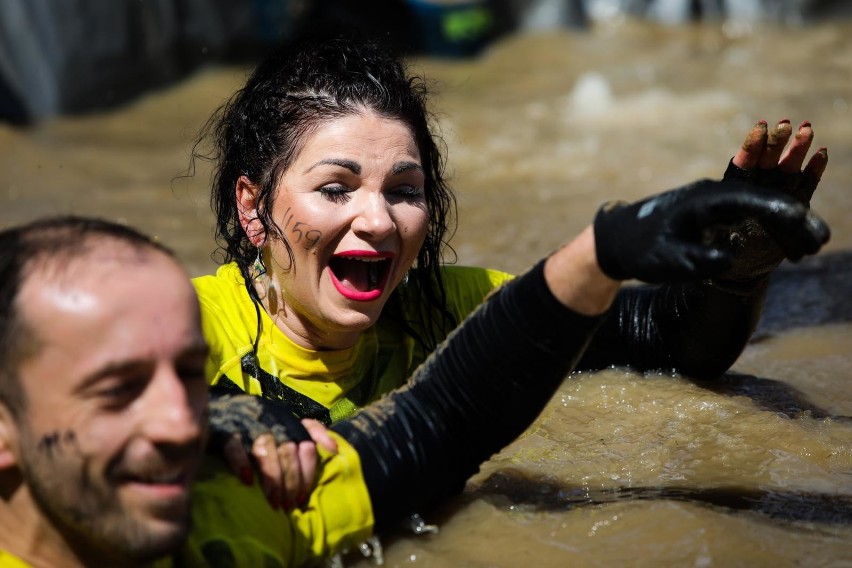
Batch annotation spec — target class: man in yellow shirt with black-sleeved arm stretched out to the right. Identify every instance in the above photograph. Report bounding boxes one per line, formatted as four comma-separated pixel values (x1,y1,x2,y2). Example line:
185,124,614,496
0,169,828,566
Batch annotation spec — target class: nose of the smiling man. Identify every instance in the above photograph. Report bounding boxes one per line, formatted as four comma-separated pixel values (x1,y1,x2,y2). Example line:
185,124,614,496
143,368,207,445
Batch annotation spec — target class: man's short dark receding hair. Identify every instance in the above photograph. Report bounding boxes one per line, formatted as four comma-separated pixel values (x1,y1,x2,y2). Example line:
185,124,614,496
0,216,175,416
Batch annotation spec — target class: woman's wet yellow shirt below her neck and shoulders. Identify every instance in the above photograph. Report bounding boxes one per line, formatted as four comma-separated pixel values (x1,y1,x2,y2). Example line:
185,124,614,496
193,263,512,423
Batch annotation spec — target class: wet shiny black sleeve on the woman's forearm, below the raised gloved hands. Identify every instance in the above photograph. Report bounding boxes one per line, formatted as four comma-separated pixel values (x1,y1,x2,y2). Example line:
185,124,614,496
577,276,769,379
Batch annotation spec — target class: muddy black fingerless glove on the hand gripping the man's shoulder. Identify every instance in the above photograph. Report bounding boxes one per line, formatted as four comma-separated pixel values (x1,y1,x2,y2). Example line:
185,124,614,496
207,387,311,455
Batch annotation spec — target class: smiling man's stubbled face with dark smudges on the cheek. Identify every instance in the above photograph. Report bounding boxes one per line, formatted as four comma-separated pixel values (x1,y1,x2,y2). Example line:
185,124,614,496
9,245,207,558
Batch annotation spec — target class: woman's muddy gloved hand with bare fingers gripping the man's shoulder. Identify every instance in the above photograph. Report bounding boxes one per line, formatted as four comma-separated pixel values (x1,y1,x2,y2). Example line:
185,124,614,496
209,393,337,511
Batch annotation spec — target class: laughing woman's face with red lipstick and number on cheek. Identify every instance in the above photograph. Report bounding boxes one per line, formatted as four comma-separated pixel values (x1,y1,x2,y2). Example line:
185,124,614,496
237,110,429,349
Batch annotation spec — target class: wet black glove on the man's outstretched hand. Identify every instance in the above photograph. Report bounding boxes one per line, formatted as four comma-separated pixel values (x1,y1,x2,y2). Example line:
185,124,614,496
594,179,830,283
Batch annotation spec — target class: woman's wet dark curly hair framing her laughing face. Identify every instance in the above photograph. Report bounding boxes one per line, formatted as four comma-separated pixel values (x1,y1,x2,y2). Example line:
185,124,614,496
190,36,457,350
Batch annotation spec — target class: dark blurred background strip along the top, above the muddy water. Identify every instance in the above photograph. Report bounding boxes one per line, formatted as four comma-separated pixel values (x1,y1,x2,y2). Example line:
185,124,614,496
0,0,852,123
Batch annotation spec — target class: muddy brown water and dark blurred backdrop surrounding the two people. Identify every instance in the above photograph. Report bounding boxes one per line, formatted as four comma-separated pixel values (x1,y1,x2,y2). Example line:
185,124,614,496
0,0,852,568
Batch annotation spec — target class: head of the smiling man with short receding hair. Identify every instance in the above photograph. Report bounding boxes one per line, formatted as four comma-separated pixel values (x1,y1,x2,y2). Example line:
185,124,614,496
0,216,207,566
